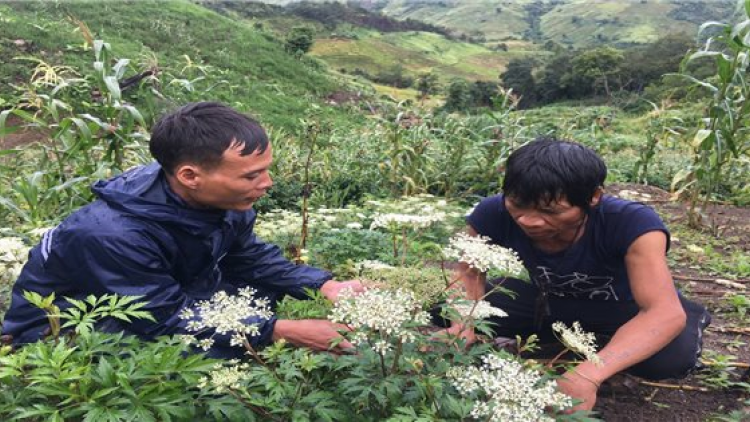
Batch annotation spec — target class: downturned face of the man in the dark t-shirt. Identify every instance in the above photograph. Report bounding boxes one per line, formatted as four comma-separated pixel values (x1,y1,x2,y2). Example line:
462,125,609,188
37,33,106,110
505,197,586,241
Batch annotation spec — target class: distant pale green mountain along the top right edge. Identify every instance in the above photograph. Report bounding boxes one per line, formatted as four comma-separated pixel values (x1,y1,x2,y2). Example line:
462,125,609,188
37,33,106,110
256,0,737,48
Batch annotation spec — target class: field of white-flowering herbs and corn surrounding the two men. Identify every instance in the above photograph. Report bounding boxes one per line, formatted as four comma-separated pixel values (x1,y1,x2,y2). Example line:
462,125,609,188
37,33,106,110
0,1,750,421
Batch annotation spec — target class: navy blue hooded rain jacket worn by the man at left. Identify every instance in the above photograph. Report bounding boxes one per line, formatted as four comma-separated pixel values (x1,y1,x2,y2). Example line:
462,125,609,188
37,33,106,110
3,164,331,355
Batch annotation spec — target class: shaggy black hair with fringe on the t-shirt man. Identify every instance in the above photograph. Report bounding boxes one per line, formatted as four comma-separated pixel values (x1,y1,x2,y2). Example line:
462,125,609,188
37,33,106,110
503,137,607,210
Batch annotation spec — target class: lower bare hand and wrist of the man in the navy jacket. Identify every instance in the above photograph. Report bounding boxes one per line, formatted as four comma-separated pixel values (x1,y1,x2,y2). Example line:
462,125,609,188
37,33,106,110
273,319,354,353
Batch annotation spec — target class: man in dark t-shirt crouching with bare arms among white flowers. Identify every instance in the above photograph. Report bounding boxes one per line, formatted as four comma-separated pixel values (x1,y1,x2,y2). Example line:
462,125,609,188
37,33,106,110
451,138,710,409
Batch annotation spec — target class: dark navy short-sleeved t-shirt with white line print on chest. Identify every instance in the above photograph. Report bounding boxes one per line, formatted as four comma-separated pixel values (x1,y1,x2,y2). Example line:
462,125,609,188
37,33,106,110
466,195,669,301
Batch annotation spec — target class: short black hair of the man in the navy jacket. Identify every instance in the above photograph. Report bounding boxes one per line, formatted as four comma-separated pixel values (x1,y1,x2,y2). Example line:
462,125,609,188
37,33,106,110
149,102,268,174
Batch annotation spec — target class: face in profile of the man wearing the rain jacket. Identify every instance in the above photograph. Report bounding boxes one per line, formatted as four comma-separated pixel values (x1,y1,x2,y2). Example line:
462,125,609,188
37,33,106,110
187,144,273,211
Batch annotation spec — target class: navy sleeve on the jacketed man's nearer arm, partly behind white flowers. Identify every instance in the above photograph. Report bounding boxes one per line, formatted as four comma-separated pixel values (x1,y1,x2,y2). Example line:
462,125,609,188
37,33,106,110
48,231,276,347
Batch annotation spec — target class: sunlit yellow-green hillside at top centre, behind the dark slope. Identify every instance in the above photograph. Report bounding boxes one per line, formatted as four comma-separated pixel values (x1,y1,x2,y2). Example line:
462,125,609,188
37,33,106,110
201,1,540,86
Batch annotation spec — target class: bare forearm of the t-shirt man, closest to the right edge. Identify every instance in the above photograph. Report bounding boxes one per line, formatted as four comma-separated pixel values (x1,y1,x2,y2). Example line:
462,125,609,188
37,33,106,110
576,311,685,383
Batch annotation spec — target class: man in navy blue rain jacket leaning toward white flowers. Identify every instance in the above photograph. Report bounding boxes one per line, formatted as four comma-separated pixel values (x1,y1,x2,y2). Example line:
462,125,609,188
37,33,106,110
3,102,362,357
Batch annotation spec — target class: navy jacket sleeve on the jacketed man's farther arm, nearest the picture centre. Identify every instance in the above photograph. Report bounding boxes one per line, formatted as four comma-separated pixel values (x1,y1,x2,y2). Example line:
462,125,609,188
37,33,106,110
221,212,333,299
